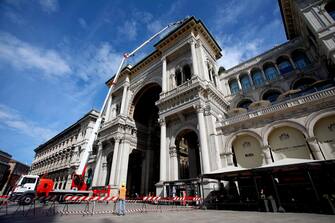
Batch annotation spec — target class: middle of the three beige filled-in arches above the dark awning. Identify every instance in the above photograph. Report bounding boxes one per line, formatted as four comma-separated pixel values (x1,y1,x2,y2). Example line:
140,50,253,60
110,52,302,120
268,126,312,161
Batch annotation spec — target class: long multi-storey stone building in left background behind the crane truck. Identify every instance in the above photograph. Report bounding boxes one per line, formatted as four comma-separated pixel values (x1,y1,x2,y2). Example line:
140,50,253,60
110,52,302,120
30,110,99,189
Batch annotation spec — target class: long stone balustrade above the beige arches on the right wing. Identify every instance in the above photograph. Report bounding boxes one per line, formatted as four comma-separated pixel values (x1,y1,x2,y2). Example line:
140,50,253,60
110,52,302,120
219,87,335,127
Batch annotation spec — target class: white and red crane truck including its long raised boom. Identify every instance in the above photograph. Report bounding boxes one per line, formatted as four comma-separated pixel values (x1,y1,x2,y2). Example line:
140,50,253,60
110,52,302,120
10,17,190,204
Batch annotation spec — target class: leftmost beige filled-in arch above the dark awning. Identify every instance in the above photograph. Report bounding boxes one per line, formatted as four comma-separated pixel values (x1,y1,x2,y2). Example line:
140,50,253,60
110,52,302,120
233,135,265,168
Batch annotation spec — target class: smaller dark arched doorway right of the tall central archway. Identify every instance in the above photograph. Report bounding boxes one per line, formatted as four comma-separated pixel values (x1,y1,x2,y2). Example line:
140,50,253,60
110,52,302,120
176,130,201,179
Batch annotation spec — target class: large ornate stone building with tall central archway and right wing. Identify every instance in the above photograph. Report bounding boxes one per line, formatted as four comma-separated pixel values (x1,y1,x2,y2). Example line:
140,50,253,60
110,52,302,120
33,0,335,206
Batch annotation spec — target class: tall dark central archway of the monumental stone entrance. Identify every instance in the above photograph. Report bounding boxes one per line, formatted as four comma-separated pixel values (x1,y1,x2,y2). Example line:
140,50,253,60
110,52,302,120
127,83,162,196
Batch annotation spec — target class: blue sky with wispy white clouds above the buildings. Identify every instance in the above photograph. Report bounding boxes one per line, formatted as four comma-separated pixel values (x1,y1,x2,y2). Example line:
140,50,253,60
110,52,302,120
0,0,286,163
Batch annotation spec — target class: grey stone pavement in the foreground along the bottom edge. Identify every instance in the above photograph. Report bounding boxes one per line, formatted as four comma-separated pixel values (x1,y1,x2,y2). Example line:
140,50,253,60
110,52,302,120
0,210,335,223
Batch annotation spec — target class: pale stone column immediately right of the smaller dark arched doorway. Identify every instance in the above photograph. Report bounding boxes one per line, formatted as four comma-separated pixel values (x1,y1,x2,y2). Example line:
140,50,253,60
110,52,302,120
195,105,211,173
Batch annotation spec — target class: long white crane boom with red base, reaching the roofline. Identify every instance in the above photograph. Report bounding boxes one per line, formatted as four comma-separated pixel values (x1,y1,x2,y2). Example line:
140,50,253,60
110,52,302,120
72,18,188,190
